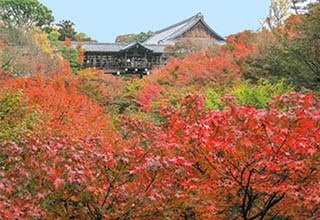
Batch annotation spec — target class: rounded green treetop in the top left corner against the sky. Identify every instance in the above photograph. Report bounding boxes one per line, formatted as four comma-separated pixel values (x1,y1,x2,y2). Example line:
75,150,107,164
0,0,54,27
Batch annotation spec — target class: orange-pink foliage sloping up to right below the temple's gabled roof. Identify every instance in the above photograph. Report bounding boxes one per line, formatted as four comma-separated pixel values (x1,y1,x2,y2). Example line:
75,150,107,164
129,41,253,110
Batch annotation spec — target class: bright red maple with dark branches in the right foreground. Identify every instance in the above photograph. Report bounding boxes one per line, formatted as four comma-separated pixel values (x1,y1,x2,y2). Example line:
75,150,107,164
159,93,320,219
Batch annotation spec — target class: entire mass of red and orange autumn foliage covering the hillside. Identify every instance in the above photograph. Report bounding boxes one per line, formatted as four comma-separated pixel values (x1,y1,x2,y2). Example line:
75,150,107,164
0,12,320,220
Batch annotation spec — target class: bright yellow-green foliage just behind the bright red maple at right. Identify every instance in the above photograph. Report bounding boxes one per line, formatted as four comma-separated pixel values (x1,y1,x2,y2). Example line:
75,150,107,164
206,79,293,109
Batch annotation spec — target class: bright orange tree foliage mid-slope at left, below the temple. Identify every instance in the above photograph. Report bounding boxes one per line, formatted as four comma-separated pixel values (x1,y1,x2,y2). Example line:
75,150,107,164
1,62,109,136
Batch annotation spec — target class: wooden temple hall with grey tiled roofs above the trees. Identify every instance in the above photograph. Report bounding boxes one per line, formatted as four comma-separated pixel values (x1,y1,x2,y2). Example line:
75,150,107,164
73,13,225,76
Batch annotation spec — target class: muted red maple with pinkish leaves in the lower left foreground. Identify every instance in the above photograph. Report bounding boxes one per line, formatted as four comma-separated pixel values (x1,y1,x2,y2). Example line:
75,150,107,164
0,133,179,219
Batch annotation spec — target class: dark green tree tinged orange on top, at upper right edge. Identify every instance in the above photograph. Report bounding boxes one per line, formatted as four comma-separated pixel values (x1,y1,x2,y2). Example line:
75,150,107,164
267,3,320,90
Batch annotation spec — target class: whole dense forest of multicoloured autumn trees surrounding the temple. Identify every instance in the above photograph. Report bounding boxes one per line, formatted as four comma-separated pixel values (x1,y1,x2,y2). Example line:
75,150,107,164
0,0,320,220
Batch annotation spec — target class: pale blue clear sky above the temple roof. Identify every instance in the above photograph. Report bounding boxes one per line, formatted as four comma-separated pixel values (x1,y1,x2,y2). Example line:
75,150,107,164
39,0,270,42
